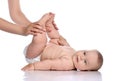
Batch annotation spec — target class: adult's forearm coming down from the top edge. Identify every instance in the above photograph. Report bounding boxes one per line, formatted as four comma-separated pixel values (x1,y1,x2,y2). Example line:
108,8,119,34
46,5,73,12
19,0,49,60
8,0,31,26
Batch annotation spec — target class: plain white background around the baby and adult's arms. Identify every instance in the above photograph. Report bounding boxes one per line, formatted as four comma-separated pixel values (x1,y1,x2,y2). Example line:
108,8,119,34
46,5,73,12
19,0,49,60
0,0,120,81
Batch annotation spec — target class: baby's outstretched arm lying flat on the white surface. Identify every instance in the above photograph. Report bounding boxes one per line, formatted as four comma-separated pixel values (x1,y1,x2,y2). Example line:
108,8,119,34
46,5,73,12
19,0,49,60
22,58,74,71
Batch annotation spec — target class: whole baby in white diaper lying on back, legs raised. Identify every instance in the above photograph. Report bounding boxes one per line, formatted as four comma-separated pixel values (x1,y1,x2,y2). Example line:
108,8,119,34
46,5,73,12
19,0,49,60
22,13,103,71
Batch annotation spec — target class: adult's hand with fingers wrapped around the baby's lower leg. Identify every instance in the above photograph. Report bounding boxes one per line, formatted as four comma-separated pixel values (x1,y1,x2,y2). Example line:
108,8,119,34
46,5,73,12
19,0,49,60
24,23,46,35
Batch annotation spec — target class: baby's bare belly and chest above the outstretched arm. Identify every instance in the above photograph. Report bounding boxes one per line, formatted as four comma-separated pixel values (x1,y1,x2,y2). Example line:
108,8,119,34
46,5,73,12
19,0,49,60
41,44,75,60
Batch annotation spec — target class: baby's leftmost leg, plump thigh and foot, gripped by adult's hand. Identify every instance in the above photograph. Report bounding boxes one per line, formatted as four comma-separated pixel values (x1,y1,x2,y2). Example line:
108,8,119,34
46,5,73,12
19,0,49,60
26,13,52,58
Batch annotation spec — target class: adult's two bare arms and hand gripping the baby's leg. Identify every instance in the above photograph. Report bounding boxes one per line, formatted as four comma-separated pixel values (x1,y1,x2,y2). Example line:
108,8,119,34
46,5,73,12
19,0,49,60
0,0,44,36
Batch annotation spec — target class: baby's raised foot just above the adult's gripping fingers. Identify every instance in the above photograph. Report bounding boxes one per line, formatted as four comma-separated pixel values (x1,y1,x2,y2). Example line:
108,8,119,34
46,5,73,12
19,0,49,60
38,13,54,28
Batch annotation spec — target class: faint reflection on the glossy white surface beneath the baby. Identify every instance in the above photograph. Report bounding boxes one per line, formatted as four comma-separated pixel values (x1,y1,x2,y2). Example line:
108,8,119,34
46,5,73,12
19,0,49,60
24,71,102,81
